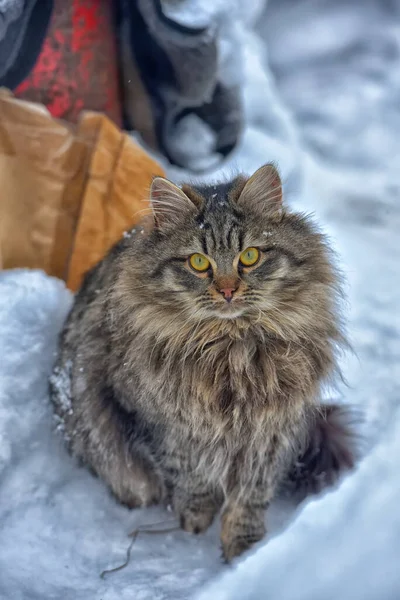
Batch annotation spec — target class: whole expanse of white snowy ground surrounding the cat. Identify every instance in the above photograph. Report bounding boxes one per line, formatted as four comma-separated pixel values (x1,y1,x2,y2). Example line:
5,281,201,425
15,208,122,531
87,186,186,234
0,0,400,600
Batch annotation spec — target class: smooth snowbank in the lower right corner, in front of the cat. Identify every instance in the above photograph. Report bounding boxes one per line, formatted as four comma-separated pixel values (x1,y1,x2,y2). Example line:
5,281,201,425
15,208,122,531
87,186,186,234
197,410,400,600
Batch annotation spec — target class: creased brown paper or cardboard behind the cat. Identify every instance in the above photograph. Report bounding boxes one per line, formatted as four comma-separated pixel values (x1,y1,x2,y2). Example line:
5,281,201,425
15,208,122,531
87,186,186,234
0,90,163,291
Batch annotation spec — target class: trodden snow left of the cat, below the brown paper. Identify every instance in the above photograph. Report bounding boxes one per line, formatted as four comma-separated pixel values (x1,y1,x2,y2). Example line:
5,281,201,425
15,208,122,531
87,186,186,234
0,271,225,600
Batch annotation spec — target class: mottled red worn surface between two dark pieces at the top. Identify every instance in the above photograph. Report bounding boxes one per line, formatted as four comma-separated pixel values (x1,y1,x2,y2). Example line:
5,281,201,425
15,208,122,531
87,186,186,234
14,0,122,126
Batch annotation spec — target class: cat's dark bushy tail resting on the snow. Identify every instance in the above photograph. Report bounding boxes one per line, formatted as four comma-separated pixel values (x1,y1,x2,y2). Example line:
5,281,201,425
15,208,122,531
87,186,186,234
284,404,360,497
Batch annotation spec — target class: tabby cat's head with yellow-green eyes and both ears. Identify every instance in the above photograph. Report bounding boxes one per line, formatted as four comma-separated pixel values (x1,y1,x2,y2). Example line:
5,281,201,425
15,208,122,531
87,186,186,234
127,164,335,336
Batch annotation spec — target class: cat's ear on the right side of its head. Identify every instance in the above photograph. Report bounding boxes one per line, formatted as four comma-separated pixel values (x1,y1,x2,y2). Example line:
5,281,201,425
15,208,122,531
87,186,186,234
237,164,282,219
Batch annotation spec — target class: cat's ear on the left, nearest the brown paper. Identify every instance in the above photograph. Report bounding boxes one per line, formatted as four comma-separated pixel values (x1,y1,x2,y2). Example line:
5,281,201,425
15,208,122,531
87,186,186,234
150,177,196,230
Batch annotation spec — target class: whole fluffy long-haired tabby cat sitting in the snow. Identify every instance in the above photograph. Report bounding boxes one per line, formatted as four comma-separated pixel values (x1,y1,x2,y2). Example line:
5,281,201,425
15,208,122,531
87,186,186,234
51,165,353,560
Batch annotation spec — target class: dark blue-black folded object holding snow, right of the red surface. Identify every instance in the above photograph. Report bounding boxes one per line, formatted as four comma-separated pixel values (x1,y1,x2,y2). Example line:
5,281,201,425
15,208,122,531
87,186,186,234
119,0,243,170
